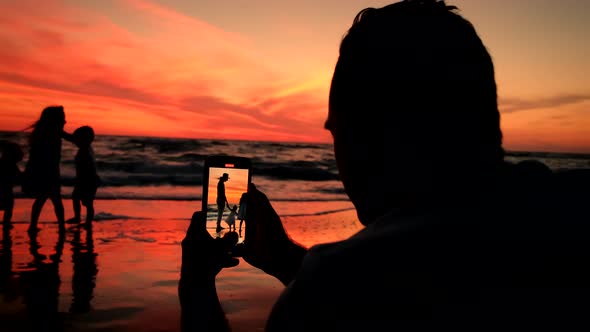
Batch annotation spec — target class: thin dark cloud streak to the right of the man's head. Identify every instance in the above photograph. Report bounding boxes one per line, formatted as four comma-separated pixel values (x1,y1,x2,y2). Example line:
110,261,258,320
499,94,590,113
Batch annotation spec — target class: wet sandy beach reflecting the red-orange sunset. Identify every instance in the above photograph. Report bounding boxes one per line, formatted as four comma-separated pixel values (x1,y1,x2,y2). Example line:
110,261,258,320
0,199,361,332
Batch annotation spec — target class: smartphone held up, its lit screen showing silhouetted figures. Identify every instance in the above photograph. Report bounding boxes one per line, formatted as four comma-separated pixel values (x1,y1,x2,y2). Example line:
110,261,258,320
201,155,252,242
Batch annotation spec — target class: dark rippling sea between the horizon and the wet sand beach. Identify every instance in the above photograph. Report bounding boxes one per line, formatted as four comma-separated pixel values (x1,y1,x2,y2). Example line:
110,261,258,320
0,132,590,208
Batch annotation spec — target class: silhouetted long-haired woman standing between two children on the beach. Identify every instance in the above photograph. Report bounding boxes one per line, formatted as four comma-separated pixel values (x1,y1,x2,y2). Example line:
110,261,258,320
22,106,69,232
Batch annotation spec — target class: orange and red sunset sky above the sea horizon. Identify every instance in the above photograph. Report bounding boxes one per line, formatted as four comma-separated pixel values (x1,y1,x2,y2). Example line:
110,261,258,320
0,0,590,153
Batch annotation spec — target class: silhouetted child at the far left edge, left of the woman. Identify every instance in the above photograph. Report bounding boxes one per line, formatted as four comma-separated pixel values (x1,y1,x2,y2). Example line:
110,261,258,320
0,142,24,227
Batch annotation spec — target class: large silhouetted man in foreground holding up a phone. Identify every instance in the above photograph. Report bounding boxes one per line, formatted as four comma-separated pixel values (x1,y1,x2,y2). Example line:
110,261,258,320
179,0,590,332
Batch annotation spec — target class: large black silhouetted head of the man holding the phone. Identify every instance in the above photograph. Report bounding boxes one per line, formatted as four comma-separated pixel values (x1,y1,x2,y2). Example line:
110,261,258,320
326,0,504,221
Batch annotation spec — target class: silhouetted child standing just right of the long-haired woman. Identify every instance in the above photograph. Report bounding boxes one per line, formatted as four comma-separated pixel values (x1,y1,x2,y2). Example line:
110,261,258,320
68,126,100,227
